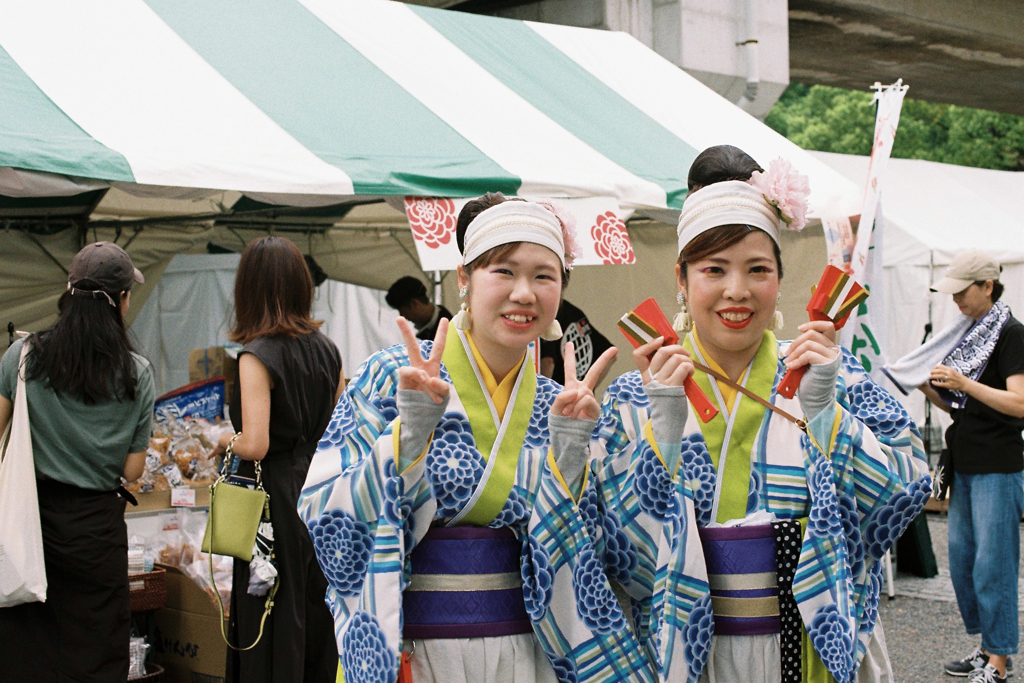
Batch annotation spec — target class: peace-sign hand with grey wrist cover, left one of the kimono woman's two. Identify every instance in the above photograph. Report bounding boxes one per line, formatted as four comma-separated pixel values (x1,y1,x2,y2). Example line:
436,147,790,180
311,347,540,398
395,316,450,472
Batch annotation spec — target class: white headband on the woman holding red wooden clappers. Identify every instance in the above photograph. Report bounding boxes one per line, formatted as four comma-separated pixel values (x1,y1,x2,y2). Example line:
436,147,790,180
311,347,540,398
676,180,782,253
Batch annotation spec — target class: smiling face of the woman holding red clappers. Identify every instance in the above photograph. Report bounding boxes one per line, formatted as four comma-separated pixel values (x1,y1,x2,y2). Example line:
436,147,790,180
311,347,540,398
677,229,779,366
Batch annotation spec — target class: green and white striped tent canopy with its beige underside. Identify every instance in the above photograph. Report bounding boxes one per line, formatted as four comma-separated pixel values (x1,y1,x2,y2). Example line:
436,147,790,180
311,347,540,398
0,0,861,333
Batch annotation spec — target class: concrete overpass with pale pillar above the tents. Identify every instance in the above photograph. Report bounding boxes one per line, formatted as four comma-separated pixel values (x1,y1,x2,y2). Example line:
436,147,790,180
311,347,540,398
409,0,1024,118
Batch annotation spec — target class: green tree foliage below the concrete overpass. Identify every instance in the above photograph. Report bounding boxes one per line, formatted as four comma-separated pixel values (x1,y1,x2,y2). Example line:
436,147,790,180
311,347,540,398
765,83,1024,171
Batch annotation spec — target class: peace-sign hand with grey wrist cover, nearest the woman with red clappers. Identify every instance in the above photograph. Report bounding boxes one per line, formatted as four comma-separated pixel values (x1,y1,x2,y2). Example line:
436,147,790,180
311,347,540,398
548,342,618,500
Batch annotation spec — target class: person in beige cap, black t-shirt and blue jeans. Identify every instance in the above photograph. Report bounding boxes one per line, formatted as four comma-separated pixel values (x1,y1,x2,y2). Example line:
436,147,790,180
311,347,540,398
921,250,1024,683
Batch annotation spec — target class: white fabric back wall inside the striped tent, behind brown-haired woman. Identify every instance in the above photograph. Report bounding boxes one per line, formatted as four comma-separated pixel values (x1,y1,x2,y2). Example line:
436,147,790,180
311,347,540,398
131,254,401,393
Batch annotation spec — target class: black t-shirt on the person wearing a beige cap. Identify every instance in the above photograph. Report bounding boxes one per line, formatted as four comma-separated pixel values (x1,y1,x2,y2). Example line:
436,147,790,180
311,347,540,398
946,316,1024,474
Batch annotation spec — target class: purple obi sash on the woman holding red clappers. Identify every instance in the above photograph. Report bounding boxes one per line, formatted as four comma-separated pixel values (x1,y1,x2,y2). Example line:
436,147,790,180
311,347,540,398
699,524,781,636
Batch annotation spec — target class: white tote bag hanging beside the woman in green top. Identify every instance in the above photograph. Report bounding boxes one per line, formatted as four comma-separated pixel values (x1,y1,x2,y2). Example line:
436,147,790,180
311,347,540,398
0,341,46,607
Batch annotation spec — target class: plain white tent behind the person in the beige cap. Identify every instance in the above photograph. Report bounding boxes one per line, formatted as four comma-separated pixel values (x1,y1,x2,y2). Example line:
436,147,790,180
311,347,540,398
811,152,1024,420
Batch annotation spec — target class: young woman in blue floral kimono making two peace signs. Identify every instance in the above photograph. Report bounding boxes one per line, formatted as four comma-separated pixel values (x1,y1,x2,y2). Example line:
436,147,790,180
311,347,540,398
299,195,656,683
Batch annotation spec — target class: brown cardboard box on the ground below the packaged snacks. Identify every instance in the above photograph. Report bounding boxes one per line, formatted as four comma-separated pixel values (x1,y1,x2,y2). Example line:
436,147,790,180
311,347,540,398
153,565,227,683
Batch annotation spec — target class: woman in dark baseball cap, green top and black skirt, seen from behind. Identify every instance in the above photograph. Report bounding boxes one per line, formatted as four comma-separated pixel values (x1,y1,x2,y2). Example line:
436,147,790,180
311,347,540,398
0,242,155,683
